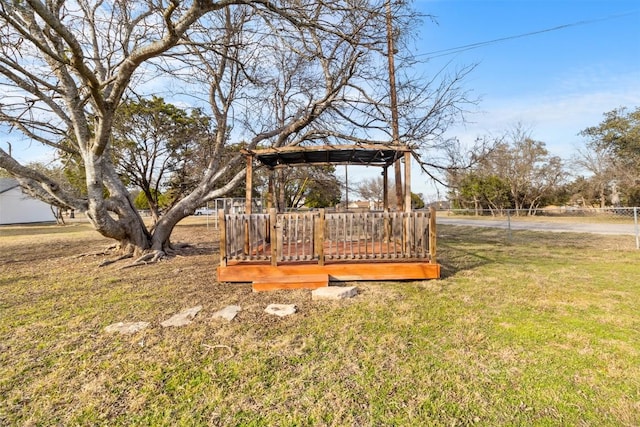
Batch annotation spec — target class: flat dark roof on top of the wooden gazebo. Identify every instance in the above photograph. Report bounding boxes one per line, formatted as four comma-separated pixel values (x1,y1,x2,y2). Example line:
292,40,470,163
246,144,411,169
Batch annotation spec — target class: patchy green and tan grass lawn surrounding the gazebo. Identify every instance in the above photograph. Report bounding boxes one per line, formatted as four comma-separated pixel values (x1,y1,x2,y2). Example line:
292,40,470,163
0,219,640,426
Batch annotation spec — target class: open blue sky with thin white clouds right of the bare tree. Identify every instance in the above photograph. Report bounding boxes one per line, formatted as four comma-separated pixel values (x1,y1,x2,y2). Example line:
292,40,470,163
350,0,640,200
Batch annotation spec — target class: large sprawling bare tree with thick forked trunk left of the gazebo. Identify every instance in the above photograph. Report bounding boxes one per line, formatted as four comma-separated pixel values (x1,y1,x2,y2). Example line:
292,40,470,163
0,0,478,261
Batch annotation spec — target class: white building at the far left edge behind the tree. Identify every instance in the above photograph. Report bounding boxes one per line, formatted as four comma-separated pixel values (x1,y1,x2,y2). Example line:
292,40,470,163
0,178,56,225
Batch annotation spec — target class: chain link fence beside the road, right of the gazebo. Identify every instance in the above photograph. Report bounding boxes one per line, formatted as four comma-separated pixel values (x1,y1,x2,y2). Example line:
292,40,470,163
437,207,640,249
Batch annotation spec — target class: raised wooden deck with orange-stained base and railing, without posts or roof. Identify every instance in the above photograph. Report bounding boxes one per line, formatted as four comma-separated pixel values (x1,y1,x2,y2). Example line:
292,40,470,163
218,210,440,290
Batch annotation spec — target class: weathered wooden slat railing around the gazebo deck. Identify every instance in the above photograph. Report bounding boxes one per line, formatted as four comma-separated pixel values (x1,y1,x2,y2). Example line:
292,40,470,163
219,209,436,266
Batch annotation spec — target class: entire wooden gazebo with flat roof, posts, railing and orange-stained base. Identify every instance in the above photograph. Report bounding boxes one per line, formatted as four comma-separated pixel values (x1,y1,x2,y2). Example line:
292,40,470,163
218,144,440,291
